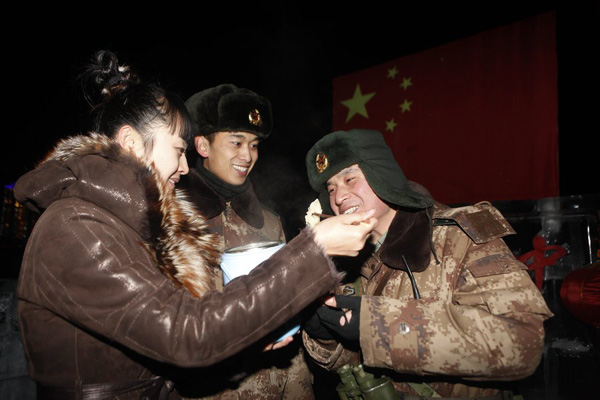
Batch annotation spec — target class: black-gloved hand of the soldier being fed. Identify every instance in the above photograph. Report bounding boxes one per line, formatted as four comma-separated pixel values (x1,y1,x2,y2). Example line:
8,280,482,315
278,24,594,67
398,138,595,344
309,295,362,341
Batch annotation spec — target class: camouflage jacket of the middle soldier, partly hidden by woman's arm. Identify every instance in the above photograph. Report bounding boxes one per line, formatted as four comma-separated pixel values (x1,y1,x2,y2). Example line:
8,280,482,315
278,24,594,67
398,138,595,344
180,170,314,400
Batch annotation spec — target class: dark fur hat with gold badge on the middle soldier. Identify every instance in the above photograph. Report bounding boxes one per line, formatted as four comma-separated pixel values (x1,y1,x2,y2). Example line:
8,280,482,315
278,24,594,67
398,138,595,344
185,83,273,139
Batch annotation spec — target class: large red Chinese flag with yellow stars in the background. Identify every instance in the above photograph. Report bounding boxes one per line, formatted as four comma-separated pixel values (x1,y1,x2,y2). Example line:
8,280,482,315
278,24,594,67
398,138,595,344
333,12,558,204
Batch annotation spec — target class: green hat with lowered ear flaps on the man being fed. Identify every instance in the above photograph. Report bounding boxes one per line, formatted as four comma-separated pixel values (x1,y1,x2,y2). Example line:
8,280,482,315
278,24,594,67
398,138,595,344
306,129,433,213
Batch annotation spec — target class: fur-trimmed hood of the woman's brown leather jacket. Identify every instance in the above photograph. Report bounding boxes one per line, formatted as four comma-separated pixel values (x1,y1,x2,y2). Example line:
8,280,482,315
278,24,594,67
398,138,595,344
15,133,219,296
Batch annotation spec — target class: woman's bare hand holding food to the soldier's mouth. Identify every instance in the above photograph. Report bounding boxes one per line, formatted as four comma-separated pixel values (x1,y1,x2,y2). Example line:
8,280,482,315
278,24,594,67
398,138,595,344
313,210,377,257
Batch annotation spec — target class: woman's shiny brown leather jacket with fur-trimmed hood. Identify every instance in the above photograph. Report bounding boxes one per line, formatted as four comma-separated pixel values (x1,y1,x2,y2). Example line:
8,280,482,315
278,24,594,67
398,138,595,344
15,134,340,399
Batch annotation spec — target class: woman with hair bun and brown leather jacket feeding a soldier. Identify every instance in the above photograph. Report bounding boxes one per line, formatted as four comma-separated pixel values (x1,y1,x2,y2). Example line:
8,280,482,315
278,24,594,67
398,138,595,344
15,52,377,399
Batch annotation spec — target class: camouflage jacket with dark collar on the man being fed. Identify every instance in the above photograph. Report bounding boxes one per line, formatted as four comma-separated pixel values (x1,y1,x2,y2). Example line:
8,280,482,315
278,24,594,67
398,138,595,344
303,203,552,397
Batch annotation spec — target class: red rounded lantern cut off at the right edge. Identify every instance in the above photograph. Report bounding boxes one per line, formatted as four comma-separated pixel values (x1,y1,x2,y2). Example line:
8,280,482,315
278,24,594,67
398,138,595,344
560,262,600,327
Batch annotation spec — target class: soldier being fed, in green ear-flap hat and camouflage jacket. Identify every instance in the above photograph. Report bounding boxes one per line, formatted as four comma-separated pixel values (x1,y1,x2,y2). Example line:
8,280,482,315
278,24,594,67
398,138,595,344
303,130,552,399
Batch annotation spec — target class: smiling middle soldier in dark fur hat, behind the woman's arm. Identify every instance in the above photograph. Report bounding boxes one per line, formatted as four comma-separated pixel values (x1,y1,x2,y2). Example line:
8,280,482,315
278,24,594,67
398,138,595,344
179,84,314,400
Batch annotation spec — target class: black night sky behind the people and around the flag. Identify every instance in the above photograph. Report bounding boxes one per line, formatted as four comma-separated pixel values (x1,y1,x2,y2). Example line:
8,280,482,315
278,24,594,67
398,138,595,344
1,1,600,234
